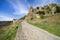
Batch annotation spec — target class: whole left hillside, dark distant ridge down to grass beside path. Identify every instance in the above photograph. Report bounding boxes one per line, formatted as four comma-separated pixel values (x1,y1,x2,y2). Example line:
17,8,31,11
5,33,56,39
0,19,22,40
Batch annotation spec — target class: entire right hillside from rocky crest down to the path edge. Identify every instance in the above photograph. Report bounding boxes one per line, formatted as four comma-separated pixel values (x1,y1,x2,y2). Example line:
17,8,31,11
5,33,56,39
25,4,60,36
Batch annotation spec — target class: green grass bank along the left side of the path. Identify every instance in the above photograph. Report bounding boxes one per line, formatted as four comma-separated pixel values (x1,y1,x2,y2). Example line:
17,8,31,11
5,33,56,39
0,22,20,40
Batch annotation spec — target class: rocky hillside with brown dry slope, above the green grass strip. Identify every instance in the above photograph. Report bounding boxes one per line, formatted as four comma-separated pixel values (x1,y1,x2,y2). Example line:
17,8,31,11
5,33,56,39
25,3,60,23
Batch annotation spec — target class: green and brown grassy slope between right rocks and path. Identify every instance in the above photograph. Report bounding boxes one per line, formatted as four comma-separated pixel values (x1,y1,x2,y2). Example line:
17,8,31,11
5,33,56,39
29,14,60,36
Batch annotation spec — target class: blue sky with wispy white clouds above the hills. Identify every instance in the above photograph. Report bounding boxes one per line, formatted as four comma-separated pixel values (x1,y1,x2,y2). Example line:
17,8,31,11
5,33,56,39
0,0,60,21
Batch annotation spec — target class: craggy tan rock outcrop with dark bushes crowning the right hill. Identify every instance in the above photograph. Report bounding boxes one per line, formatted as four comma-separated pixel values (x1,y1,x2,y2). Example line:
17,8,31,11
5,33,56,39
26,3,60,20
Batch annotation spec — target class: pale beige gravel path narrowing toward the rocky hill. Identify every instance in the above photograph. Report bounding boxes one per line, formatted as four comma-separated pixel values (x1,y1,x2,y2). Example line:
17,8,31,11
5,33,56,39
15,21,60,40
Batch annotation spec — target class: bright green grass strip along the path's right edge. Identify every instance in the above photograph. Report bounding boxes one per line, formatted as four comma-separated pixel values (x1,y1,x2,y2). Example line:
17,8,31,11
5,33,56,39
28,20,60,37
